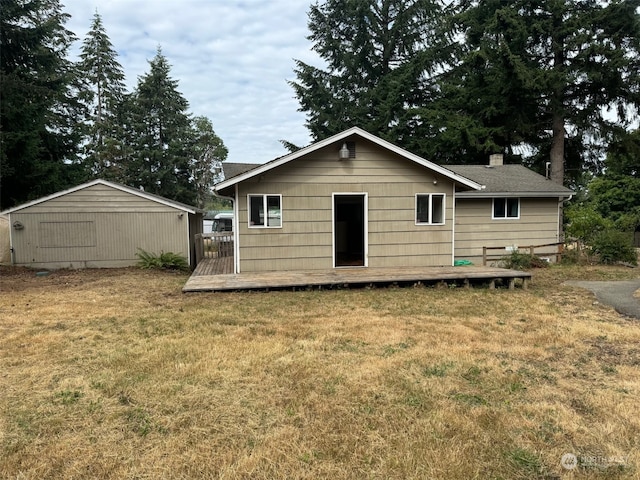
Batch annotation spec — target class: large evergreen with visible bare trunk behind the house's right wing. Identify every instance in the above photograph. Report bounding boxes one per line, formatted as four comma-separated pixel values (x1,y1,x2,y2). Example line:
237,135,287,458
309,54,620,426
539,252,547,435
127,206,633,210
441,0,640,183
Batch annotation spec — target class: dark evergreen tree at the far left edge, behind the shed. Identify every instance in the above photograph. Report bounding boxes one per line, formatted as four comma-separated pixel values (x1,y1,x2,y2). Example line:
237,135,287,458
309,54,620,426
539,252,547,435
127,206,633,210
0,0,81,209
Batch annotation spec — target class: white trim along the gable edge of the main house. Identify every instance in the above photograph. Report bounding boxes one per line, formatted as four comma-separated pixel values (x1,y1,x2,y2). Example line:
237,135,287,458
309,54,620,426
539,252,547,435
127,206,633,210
214,127,482,192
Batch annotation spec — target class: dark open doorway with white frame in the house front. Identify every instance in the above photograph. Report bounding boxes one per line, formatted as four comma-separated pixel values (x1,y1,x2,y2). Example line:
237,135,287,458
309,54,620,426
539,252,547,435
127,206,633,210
333,194,366,267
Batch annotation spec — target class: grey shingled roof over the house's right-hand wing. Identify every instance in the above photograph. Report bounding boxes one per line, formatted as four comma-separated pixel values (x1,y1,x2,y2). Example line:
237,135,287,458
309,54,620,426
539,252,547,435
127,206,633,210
448,165,573,197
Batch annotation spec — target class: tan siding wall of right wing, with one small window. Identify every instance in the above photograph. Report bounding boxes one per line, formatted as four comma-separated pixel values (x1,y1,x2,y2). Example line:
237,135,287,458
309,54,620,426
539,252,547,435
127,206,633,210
455,197,560,265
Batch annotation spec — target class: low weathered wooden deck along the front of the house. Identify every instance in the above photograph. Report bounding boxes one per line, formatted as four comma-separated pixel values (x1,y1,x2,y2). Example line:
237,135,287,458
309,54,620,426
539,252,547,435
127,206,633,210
182,257,532,293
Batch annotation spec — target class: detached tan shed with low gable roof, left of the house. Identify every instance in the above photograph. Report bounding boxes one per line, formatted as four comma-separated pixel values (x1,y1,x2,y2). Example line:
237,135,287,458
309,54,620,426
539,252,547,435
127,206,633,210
2,180,202,268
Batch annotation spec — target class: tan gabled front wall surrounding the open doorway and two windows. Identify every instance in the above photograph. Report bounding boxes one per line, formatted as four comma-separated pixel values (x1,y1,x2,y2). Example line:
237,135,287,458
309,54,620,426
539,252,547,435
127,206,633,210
236,139,454,272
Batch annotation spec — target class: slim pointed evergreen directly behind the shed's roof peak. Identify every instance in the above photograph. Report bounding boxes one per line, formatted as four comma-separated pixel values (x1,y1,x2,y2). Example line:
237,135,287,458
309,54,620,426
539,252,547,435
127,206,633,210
79,12,125,180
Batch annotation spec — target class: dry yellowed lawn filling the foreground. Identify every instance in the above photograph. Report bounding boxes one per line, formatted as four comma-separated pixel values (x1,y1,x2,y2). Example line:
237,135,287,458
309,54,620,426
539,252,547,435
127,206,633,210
0,267,640,480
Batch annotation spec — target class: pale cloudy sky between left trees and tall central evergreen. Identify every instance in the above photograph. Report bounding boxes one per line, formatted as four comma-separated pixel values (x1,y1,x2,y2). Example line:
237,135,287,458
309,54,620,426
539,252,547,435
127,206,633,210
61,0,322,163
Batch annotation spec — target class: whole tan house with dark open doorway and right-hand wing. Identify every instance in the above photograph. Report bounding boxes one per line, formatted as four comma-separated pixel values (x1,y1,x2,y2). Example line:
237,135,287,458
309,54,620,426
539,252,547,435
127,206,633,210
215,127,571,273
